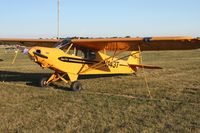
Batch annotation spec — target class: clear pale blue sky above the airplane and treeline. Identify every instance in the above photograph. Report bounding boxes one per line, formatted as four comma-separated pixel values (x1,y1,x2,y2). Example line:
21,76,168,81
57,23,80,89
0,0,200,38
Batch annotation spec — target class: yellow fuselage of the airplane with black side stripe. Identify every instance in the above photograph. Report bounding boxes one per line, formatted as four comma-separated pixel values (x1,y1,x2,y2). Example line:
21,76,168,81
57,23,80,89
29,47,138,75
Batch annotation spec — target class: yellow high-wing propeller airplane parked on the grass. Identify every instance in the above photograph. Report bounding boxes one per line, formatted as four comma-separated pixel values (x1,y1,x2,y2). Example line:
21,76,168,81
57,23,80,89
0,37,200,91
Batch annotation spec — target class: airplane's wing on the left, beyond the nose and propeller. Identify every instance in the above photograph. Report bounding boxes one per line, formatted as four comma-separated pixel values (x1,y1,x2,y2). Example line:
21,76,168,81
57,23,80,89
0,38,61,47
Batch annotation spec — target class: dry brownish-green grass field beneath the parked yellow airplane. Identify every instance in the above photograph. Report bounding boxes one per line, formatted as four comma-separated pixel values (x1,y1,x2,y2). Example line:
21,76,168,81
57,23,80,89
0,49,200,133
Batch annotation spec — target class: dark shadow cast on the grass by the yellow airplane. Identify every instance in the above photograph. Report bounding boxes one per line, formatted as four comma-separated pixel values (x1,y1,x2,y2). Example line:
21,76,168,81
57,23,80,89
0,71,130,90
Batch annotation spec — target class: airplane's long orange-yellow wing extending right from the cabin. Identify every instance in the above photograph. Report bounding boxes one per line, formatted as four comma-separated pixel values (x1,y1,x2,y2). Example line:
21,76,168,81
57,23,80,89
71,37,200,51
